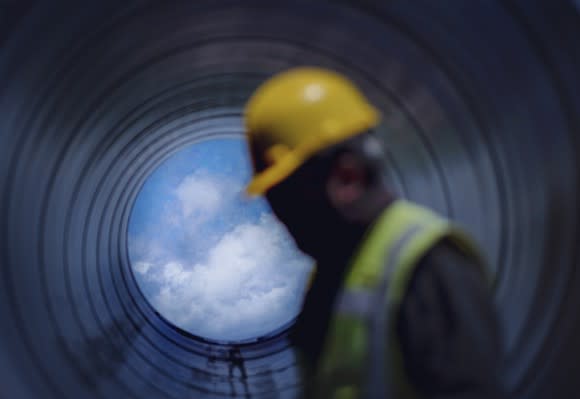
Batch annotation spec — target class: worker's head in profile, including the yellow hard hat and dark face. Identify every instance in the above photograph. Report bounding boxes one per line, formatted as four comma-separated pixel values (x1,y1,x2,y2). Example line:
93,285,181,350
245,68,384,255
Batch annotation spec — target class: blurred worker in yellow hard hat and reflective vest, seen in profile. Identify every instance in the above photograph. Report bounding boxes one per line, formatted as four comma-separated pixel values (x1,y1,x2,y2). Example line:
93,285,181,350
245,67,501,398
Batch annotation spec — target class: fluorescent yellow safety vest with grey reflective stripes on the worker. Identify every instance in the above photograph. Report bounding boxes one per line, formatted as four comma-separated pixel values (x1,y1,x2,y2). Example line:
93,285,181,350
314,201,484,399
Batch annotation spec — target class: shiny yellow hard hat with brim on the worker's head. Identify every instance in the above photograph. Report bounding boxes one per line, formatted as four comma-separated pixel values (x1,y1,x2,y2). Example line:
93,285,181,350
245,67,380,195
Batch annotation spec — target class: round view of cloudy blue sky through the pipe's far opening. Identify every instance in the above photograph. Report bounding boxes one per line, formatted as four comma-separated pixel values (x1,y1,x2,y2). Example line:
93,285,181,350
129,138,312,340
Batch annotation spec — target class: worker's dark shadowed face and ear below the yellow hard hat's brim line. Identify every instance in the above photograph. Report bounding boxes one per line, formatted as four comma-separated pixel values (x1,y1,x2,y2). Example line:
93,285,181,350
258,131,383,260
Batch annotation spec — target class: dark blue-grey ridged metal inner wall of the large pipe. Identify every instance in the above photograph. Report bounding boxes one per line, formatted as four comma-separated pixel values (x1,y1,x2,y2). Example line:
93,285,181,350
0,0,580,398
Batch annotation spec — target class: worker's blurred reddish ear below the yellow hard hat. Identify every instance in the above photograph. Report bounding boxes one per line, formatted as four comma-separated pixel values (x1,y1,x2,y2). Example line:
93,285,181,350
326,152,366,211
